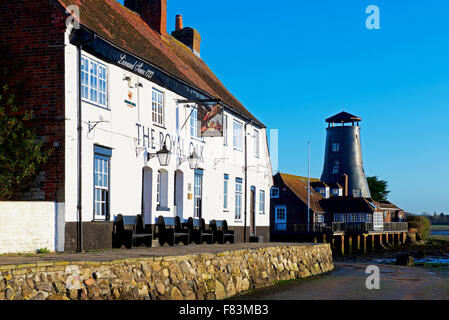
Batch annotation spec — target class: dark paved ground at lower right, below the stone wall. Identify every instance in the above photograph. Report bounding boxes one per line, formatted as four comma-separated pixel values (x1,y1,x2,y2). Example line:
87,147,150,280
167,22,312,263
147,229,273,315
236,262,449,300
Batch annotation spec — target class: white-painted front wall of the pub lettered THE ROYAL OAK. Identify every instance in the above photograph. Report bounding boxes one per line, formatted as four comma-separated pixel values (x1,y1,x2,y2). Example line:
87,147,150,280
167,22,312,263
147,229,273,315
65,36,272,231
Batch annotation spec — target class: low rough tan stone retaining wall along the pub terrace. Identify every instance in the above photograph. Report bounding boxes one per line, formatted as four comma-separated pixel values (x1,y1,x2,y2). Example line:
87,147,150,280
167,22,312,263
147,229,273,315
0,244,334,300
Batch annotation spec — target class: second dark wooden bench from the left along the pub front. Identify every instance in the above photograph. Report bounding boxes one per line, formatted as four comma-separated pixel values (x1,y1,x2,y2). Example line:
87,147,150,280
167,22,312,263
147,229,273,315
157,216,190,246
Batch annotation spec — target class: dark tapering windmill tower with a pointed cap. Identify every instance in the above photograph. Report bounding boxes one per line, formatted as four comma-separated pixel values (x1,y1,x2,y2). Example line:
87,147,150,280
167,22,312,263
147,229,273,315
321,112,371,198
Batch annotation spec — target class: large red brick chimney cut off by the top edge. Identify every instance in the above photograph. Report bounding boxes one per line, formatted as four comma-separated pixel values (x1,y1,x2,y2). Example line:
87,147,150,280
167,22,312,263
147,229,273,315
125,0,167,35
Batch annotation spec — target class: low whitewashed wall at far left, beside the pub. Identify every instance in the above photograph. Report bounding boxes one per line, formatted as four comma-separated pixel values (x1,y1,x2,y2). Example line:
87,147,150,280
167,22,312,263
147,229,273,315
0,201,65,253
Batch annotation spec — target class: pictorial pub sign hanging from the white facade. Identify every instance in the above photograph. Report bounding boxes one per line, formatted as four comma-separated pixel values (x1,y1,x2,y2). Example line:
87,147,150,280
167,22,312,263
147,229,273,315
197,103,223,137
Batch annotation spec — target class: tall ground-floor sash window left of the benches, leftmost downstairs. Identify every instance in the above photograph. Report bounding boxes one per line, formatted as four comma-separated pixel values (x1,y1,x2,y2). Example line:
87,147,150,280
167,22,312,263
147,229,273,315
94,146,112,220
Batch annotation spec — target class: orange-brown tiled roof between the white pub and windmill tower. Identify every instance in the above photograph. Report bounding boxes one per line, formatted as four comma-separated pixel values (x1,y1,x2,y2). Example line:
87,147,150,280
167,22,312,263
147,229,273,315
278,172,324,213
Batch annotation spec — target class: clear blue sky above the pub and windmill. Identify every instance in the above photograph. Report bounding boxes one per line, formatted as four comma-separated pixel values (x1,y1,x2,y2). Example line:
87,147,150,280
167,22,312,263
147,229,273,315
118,0,449,213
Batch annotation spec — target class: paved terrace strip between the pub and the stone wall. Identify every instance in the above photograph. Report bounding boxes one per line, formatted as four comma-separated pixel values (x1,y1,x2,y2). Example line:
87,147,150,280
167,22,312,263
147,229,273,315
0,242,313,265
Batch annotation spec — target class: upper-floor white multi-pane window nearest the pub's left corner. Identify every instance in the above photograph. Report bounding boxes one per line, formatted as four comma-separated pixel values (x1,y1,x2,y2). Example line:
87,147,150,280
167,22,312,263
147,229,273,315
81,56,108,108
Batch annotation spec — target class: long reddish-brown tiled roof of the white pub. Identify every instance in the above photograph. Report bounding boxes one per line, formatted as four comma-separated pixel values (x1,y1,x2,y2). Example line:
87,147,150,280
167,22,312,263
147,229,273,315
57,0,263,125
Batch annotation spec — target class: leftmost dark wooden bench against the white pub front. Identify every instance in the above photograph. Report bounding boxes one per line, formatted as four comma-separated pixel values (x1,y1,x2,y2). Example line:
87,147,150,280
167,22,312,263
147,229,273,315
112,214,153,249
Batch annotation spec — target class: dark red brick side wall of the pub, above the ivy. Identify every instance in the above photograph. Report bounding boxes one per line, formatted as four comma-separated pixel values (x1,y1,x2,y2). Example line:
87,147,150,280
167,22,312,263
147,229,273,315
0,0,66,201
